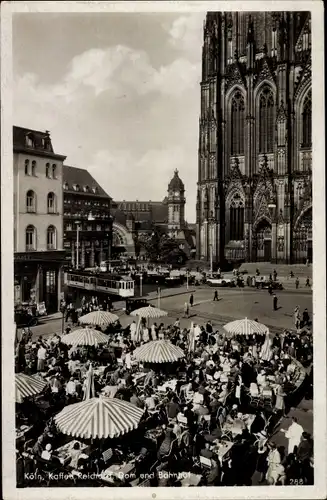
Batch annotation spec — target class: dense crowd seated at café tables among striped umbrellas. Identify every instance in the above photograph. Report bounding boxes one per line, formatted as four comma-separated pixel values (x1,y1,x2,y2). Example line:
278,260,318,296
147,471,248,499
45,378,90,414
16,299,313,486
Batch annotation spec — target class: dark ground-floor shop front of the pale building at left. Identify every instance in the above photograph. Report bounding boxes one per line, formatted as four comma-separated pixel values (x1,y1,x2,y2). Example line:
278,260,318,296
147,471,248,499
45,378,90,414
14,251,65,314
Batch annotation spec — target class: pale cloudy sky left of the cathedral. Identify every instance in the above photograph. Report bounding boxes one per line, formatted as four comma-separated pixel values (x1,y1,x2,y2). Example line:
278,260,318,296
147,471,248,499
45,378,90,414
13,13,205,222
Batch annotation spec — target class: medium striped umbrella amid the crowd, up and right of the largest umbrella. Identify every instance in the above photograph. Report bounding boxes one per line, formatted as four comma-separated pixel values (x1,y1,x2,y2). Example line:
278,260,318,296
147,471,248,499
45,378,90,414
133,340,185,363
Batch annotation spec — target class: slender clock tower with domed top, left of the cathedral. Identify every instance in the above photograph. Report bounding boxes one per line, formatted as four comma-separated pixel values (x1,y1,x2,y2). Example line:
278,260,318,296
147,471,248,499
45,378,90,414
168,169,185,236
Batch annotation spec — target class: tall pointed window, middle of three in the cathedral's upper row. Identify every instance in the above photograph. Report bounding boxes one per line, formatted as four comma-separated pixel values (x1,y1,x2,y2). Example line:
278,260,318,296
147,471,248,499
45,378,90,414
259,87,275,153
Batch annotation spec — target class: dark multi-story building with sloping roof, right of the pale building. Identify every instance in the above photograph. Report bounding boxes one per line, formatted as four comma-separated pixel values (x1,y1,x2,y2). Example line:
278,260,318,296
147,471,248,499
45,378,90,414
62,165,112,268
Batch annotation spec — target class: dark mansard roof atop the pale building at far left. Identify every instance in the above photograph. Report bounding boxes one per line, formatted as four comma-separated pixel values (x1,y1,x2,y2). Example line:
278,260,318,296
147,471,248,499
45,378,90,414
13,125,66,160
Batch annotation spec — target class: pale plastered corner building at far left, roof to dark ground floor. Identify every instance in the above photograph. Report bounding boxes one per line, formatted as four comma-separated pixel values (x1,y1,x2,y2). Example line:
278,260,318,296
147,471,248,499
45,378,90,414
13,127,66,312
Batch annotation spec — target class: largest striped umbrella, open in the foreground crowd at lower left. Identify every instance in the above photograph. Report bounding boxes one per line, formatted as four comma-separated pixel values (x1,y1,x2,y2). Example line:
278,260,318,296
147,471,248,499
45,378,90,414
54,396,143,439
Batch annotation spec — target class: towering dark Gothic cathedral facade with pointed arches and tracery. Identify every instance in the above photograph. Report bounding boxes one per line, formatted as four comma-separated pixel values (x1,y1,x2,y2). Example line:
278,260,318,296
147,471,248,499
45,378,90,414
196,12,312,265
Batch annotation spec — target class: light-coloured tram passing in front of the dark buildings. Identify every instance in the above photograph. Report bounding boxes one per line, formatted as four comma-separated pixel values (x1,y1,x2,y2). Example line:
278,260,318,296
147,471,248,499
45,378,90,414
64,271,134,299
